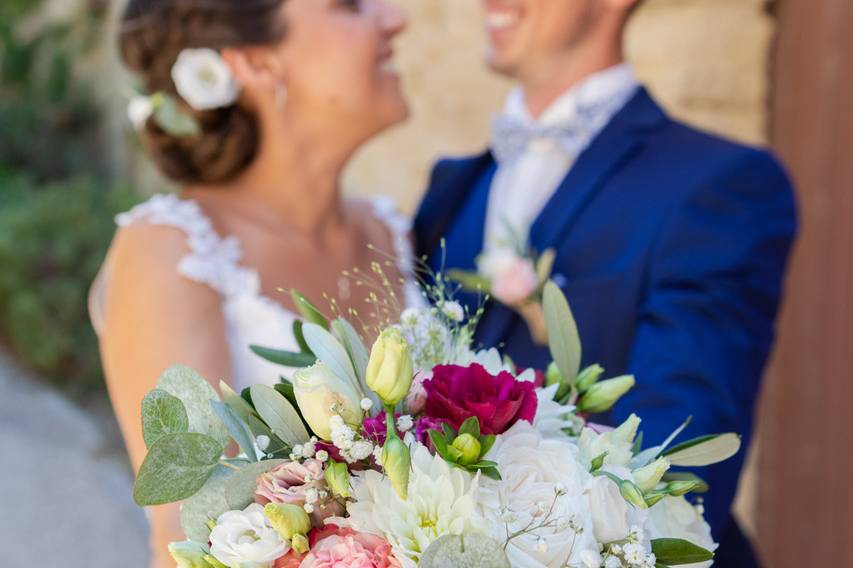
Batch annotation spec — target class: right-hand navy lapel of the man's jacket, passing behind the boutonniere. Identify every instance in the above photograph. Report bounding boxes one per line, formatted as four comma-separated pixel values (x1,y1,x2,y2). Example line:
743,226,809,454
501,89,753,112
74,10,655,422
477,88,665,346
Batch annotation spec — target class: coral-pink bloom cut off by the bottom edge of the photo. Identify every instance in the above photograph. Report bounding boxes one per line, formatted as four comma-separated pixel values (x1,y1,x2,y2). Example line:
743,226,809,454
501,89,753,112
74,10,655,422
299,528,403,568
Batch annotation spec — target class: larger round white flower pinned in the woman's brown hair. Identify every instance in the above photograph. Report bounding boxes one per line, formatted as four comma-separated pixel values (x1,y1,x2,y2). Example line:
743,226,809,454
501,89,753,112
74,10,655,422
172,48,240,111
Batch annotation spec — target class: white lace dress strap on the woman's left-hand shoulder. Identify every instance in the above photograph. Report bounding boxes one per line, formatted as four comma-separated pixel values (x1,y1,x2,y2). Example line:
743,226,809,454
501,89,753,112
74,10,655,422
116,194,260,299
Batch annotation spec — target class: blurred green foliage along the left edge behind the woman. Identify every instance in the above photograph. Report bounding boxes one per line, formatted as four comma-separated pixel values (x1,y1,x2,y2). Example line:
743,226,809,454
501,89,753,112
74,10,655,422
0,0,137,392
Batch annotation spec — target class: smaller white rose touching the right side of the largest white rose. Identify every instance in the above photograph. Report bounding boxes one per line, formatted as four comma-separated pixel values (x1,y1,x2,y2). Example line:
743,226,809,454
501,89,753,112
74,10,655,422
586,467,648,544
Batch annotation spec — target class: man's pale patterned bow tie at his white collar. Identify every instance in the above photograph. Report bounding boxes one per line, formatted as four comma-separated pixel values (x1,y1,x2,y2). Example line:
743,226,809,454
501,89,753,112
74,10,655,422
491,99,624,164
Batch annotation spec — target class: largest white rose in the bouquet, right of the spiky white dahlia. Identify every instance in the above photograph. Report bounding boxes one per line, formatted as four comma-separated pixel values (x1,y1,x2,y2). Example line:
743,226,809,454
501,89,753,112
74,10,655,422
479,422,598,568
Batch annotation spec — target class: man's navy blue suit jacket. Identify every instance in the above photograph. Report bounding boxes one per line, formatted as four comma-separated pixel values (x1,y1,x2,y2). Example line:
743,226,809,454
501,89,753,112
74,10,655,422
415,89,796,566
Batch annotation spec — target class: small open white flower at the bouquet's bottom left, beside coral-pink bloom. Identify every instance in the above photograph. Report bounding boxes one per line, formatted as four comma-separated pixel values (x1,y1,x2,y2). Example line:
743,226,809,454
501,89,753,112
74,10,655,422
210,503,290,568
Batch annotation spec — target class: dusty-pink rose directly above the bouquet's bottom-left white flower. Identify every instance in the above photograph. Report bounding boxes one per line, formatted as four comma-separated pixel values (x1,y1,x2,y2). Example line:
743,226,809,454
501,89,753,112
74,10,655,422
255,459,345,526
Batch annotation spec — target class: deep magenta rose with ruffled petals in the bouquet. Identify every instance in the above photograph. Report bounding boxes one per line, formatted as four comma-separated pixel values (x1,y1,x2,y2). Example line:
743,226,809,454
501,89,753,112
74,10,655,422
424,364,537,434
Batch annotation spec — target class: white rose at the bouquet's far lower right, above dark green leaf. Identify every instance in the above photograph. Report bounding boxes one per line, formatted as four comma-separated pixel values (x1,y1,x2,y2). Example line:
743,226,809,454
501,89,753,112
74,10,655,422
649,497,717,568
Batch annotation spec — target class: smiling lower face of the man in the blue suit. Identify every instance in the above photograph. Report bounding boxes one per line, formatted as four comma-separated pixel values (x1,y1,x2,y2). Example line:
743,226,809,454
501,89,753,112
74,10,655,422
483,0,599,79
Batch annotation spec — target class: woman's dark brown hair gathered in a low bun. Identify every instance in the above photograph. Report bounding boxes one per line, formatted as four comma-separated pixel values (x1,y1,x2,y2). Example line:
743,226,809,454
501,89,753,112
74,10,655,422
119,0,286,184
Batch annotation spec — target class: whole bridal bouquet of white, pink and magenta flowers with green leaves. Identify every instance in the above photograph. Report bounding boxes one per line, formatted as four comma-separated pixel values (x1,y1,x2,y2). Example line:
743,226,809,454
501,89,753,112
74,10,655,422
134,283,740,568
